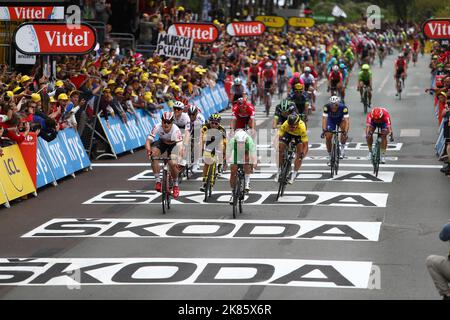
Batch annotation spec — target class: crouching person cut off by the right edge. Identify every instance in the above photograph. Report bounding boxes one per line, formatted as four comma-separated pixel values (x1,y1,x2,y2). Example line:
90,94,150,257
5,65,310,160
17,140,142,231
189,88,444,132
426,222,450,300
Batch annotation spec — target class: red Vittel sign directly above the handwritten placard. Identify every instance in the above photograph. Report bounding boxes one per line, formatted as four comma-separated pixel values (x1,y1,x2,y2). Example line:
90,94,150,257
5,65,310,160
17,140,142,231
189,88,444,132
167,23,219,43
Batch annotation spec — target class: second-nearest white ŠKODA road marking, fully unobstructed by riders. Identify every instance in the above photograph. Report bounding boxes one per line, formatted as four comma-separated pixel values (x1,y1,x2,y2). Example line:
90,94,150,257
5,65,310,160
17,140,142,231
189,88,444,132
22,218,381,241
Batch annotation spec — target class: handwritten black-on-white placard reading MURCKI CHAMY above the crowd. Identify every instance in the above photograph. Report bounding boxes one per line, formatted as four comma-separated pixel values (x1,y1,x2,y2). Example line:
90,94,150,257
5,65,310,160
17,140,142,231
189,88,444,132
156,33,194,60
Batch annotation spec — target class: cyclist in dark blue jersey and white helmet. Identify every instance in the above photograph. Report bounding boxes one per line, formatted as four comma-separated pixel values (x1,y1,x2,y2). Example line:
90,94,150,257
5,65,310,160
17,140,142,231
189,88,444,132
321,96,350,159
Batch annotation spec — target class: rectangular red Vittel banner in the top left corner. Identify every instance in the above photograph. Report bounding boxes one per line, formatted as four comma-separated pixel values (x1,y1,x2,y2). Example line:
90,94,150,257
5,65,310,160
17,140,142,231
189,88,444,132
0,6,64,21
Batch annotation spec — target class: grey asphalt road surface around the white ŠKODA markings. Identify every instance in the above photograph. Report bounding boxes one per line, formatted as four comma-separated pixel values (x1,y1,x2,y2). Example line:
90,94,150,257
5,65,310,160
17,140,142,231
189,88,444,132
0,51,450,300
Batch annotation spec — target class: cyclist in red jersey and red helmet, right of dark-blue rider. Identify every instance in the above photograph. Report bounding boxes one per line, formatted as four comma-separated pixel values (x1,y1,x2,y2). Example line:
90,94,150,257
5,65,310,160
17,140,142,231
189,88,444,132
366,107,392,164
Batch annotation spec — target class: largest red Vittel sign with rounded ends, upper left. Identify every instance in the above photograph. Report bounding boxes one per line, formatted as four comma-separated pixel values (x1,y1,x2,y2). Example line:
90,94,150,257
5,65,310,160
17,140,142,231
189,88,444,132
14,22,97,55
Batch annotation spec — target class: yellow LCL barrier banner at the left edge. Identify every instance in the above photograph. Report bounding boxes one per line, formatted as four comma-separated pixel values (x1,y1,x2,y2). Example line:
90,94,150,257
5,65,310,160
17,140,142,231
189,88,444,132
0,144,36,201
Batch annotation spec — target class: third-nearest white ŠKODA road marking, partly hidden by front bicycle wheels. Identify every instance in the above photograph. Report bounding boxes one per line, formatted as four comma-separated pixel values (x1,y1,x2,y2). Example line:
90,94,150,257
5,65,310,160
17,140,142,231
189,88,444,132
83,190,388,208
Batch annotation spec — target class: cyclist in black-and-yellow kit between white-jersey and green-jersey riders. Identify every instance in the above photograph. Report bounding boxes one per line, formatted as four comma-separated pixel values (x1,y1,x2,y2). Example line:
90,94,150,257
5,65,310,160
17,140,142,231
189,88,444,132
200,113,227,192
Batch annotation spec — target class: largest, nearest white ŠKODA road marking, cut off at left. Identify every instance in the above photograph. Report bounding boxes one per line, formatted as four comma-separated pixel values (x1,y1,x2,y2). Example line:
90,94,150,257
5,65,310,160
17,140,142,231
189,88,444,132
0,258,372,289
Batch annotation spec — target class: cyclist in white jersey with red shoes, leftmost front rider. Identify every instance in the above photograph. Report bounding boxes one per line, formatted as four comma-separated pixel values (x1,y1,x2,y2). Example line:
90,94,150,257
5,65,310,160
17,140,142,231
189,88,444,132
145,112,183,199
